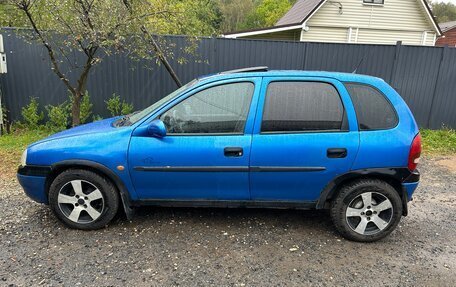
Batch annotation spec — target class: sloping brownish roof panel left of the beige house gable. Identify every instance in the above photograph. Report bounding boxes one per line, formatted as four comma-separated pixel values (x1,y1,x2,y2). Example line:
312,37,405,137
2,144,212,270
276,0,325,26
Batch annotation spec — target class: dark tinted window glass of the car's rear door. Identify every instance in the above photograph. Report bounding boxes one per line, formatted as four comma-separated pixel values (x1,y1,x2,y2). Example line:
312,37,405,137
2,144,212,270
261,82,347,132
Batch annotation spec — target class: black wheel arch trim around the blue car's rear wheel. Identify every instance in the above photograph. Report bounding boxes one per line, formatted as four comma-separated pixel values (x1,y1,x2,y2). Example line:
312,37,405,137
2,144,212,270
316,168,411,216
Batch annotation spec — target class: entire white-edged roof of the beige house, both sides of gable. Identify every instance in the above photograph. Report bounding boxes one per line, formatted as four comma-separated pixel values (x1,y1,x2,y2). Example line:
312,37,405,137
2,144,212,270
224,0,442,38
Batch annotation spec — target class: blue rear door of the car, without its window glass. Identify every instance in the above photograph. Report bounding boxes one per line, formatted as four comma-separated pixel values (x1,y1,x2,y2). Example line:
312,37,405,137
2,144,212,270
250,77,359,201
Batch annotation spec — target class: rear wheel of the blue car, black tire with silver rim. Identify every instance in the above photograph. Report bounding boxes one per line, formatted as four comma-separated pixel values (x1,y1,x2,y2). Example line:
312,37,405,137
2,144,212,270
330,179,402,242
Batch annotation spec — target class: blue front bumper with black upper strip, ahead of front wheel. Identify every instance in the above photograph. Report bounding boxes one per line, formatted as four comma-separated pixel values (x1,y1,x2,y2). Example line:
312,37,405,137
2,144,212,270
17,165,51,204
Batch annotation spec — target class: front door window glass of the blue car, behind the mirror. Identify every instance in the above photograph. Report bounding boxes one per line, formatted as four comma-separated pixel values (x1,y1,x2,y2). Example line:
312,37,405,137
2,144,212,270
160,82,255,134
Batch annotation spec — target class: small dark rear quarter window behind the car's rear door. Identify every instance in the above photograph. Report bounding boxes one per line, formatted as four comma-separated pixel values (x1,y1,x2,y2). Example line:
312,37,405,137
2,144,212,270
345,83,398,131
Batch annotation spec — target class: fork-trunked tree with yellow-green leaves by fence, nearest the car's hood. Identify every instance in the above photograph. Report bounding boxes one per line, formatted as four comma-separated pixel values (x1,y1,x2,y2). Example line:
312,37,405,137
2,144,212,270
1,0,207,126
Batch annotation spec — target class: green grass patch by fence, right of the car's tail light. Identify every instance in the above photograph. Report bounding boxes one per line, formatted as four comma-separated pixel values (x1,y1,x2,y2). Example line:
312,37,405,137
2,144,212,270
420,129,456,155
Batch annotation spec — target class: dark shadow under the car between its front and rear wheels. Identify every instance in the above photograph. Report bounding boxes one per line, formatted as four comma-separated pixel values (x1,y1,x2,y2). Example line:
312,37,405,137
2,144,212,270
111,206,336,234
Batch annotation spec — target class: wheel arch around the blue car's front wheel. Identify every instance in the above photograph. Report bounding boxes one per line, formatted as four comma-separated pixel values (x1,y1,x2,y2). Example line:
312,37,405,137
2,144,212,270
45,160,133,219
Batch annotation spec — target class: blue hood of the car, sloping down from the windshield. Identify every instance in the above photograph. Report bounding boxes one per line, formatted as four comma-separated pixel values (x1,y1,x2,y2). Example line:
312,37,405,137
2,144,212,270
31,117,119,146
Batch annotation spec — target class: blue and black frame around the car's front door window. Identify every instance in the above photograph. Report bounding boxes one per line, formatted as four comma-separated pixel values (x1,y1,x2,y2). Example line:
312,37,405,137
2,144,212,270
157,79,257,137
